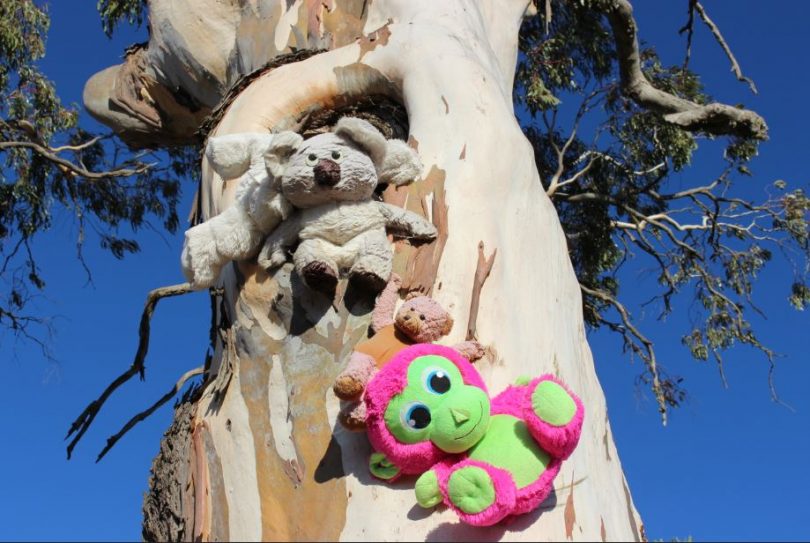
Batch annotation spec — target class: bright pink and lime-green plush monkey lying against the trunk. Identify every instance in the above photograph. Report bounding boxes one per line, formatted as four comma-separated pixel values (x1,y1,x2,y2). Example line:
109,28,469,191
365,344,584,526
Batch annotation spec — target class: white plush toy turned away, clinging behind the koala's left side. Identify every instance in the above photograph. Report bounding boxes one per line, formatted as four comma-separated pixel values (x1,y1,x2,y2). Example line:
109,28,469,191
180,132,303,288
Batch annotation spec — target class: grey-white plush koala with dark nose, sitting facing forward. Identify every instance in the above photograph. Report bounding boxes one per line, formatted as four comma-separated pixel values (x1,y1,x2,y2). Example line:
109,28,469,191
258,117,436,293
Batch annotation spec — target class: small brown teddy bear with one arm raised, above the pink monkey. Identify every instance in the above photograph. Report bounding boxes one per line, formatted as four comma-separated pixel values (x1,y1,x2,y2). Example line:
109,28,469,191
333,273,484,430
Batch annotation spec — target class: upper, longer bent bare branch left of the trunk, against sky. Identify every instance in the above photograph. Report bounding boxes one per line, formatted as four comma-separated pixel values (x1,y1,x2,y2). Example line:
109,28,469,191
65,283,192,460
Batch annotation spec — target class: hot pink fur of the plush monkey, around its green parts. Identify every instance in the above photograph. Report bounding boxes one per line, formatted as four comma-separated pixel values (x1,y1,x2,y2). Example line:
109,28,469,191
365,344,585,526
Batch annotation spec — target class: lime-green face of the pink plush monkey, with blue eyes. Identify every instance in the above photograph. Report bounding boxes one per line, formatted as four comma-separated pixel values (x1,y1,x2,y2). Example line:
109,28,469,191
385,355,490,453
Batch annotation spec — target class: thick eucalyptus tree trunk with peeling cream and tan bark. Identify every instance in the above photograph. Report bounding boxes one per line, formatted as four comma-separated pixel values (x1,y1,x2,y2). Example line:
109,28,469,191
85,0,644,541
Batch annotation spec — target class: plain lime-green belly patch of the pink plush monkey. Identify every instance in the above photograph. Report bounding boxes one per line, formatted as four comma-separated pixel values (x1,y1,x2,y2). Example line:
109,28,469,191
469,415,549,488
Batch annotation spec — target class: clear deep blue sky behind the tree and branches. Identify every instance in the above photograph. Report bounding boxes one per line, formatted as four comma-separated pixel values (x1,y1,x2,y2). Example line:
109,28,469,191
0,0,810,540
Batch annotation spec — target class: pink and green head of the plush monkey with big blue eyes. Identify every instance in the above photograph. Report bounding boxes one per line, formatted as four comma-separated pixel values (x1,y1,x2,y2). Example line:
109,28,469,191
365,344,490,473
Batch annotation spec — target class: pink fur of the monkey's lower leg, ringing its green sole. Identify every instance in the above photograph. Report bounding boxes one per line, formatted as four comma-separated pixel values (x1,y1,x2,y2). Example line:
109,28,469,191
433,459,517,526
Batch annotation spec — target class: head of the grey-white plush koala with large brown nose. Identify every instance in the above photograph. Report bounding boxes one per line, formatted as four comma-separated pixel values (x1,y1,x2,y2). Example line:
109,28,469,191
265,117,422,208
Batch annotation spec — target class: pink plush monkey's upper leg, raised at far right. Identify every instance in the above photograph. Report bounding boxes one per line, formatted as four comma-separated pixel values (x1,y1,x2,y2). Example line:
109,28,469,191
523,374,585,460
